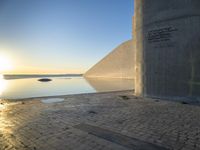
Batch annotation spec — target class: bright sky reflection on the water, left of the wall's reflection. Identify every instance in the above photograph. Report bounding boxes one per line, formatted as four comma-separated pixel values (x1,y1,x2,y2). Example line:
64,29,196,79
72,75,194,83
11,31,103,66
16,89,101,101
0,77,95,99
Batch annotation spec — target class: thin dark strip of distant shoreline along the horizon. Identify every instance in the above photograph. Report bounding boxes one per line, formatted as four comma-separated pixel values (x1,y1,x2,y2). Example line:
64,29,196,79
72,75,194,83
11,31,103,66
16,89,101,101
3,74,83,80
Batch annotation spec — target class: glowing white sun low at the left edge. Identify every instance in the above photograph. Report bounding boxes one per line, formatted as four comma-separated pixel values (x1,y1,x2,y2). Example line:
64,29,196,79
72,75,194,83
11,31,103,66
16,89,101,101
0,54,12,72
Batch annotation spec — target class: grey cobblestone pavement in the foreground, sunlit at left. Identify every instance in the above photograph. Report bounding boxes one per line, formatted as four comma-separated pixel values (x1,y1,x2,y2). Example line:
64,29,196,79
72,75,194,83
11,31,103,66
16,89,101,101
0,92,200,150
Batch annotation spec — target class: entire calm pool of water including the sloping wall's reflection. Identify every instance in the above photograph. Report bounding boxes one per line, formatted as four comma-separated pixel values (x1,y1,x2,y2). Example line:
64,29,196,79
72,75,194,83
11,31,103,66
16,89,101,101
0,76,134,99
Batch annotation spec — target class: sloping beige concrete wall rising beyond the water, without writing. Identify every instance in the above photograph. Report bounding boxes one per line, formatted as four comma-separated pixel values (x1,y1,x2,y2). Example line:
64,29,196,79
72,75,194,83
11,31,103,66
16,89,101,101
84,40,134,79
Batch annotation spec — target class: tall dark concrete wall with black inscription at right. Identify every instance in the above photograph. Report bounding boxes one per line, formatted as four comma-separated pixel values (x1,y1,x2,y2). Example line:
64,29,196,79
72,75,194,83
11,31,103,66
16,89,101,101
133,0,200,100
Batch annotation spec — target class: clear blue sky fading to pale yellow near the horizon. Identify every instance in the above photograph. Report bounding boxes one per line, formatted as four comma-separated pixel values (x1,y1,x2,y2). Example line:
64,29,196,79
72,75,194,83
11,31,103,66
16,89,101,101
0,0,133,74
